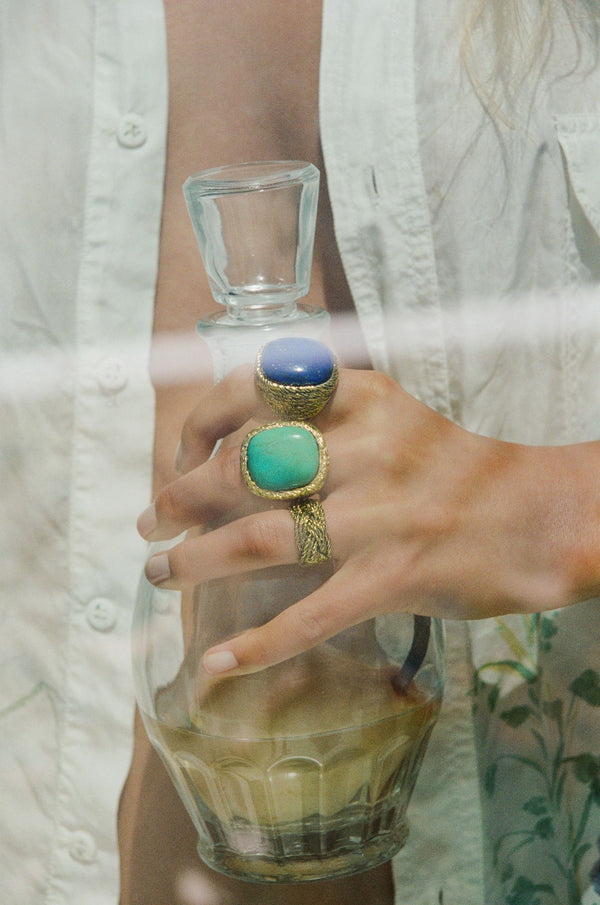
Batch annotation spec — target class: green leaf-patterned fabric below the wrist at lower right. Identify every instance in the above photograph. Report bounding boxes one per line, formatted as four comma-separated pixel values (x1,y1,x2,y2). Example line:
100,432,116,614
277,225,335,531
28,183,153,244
473,601,600,905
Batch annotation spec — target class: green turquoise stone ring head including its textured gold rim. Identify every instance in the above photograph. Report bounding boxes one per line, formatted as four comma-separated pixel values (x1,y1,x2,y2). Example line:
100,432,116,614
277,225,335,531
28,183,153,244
240,421,328,500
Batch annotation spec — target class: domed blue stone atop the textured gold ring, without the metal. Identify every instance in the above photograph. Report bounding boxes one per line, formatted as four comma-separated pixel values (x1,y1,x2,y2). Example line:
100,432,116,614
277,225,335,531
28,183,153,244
261,336,335,386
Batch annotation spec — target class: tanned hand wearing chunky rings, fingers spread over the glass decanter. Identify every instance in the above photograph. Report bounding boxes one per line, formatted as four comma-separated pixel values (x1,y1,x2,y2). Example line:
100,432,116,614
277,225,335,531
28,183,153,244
138,368,600,674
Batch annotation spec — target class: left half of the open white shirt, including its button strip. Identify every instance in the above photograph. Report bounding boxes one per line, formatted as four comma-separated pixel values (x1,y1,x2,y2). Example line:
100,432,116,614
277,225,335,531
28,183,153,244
0,0,167,905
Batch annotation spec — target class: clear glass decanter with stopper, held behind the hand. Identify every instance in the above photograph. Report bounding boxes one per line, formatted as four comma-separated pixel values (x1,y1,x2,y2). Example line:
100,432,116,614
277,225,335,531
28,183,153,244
133,161,443,882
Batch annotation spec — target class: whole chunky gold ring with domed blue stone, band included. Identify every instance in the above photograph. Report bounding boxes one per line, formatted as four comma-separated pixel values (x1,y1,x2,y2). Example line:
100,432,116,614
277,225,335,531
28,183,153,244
255,336,339,420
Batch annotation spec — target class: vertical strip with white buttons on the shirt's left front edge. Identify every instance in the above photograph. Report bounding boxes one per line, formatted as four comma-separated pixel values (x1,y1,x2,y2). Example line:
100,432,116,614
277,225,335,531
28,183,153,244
47,0,166,905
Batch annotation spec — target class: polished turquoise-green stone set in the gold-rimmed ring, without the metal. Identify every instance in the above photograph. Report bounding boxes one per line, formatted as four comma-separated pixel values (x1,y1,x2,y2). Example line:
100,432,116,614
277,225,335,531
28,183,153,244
246,424,319,492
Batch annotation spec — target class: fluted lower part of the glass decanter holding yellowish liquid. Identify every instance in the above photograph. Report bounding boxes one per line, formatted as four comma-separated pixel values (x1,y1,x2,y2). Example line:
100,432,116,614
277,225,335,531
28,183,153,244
146,701,437,883
